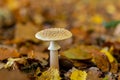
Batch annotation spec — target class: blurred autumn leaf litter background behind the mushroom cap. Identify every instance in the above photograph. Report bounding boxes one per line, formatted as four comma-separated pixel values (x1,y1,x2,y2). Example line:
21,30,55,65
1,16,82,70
0,0,120,52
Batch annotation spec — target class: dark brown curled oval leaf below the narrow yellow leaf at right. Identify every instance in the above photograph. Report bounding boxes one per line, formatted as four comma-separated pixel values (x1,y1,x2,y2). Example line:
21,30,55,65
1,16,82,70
93,51,110,72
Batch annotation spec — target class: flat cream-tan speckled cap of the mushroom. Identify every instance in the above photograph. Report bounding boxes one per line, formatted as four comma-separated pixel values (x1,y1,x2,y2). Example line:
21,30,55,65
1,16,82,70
35,28,72,41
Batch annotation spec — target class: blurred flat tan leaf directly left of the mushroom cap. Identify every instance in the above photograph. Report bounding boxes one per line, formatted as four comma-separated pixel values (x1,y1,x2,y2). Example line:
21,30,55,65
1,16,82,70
15,22,39,41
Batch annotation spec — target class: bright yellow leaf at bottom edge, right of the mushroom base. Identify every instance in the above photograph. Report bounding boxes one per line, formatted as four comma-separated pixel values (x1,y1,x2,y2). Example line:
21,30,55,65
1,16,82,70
70,69,87,80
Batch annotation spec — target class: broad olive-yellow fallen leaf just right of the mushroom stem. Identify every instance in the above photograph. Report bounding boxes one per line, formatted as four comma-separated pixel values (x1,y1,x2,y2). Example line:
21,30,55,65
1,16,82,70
63,46,92,60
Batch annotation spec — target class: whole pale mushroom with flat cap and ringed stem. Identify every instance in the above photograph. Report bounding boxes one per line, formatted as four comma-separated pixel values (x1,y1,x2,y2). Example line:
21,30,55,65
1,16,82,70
35,28,72,69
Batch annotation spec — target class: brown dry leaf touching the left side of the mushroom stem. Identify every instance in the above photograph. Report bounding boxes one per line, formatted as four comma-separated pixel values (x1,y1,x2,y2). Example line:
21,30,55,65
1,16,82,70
19,44,49,60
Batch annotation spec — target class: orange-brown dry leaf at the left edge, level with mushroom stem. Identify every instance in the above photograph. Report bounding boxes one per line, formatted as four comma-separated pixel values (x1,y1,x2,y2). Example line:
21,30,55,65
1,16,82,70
0,46,20,60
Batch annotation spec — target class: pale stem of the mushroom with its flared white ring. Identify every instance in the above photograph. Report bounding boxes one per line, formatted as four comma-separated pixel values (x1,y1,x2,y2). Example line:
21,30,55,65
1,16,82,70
48,41,60,70
